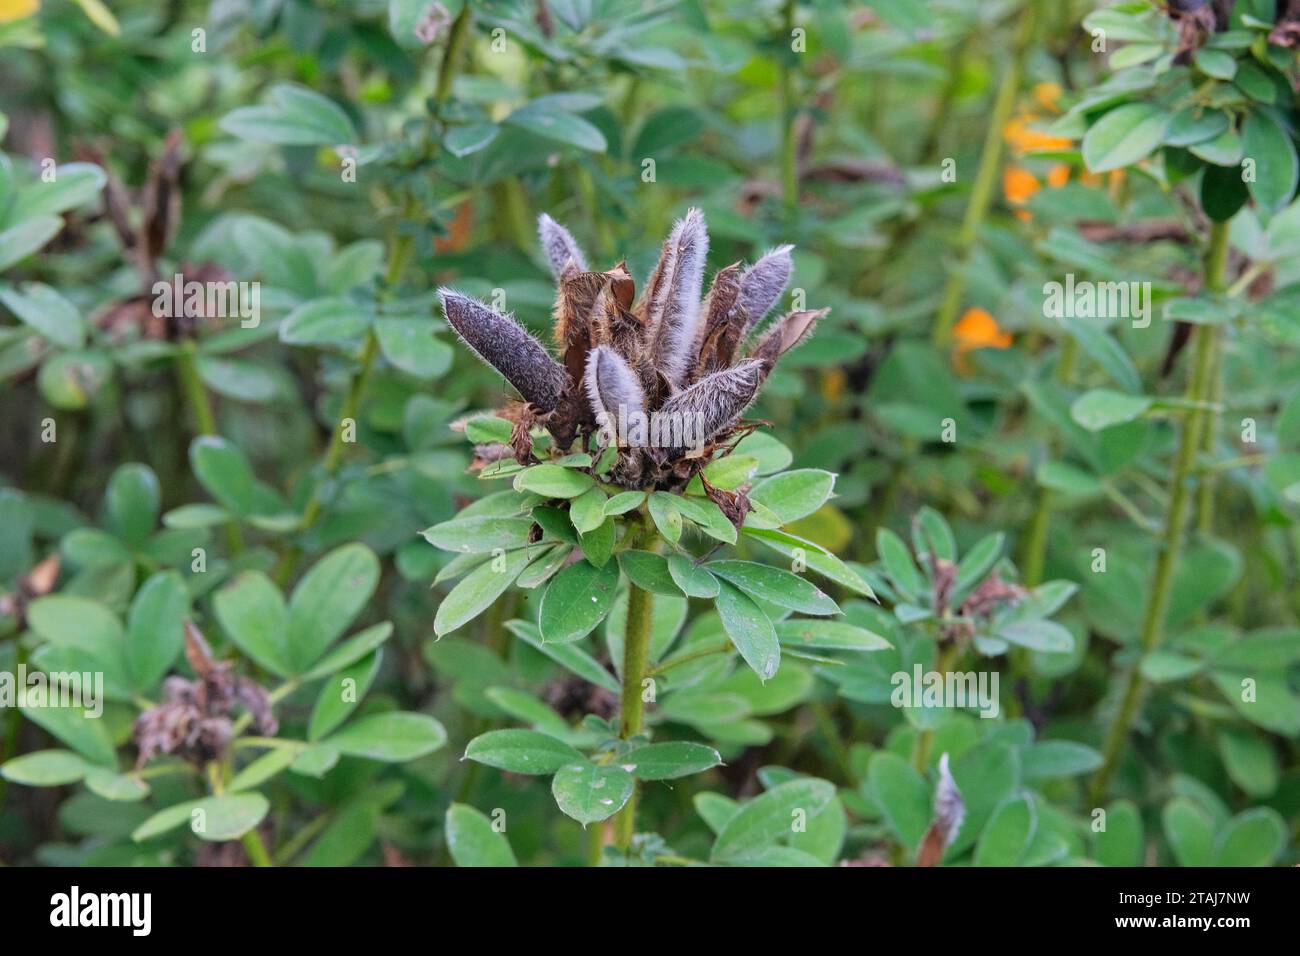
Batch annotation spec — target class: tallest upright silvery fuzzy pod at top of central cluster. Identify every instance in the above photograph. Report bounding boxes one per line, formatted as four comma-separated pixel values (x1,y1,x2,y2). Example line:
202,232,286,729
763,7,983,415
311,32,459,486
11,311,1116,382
646,208,709,385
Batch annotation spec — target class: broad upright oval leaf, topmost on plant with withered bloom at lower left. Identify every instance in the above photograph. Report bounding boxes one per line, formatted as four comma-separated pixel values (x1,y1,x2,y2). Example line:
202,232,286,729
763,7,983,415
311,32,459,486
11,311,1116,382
289,544,380,671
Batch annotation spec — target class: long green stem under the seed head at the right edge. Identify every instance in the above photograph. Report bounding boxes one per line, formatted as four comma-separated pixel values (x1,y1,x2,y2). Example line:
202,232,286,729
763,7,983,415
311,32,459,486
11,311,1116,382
1088,222,1229,805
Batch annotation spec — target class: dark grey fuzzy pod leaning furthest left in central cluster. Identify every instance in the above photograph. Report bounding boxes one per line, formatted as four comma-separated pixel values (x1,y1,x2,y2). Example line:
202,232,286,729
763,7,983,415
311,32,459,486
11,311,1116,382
438,289,571,414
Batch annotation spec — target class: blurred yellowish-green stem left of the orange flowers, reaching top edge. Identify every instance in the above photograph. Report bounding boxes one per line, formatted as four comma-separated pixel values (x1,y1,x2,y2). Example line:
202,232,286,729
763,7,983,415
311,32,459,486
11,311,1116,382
931,0,1039,346
